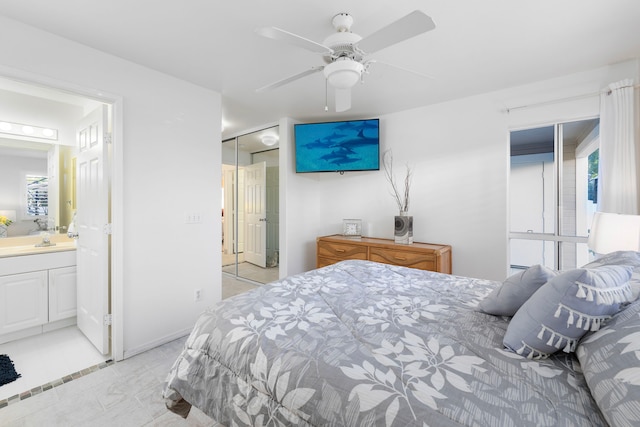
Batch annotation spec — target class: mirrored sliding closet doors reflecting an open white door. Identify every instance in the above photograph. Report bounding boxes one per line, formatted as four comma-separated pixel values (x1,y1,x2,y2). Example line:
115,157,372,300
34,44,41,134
221,126,280,284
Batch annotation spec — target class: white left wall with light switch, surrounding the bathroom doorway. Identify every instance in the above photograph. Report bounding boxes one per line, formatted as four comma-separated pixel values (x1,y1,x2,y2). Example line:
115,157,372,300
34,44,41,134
0,17,221,357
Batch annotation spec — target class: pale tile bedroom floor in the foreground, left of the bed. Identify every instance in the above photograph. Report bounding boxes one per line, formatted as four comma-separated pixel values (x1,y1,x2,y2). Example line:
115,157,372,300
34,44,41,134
0,337,220,427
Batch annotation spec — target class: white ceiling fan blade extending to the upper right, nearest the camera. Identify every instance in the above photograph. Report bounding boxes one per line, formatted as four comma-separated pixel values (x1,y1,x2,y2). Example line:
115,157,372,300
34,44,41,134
358,10,436,54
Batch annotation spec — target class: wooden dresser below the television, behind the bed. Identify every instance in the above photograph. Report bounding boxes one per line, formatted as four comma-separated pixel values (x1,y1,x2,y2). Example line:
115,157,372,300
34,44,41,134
316,234,451,274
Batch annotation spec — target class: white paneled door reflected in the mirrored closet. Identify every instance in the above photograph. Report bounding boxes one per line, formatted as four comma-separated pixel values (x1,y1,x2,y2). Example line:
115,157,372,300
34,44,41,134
244,162,267,268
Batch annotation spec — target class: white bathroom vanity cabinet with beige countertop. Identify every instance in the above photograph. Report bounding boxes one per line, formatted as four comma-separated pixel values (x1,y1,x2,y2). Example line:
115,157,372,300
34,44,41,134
0,235,76,344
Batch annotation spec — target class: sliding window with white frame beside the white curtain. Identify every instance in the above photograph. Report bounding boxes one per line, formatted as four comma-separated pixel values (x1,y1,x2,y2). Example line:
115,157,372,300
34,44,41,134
509,119,599,270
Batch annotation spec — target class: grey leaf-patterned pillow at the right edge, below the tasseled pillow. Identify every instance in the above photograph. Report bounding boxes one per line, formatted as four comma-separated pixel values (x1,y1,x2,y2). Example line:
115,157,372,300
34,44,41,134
576,301,640,426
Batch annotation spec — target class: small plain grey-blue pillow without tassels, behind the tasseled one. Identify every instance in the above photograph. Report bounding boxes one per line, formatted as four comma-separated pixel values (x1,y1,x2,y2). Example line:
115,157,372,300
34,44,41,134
478,265,556,316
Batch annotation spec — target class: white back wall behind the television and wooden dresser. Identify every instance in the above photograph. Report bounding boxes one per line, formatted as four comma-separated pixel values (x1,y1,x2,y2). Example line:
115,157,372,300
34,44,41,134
280,60,639,280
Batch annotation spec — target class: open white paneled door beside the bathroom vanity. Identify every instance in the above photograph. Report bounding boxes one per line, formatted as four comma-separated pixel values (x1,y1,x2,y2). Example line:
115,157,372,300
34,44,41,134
76,105,110,354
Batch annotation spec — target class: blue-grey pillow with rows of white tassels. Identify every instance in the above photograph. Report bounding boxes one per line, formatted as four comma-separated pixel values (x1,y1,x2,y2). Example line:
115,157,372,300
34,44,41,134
504,265,632,359
